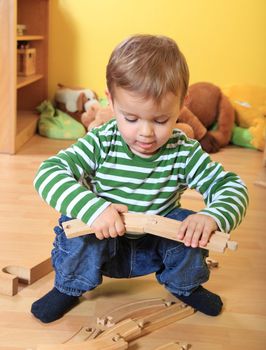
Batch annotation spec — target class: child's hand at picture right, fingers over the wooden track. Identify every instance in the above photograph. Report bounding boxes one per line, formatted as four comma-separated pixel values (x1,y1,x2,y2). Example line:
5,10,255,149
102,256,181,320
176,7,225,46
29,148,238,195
177,214,218,248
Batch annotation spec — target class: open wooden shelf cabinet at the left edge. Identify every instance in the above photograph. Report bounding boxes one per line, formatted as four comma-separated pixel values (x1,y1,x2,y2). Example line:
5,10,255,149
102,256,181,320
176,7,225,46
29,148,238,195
0,0,49,154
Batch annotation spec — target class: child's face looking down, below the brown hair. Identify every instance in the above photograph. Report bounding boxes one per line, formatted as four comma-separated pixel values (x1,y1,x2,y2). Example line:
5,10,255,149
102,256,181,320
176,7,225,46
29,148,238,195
107,88,180,157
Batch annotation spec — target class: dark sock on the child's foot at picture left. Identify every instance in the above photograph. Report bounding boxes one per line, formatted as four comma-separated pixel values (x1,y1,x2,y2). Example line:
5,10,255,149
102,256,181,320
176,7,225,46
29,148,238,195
31,288,79,323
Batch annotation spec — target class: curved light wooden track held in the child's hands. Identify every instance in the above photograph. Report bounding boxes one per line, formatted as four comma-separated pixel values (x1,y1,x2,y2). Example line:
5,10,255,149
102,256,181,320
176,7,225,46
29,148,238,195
63,213,237,253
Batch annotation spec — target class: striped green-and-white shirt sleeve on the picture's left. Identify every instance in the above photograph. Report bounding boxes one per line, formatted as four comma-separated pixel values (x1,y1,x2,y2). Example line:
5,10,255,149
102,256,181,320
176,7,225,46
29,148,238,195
34,129,111,225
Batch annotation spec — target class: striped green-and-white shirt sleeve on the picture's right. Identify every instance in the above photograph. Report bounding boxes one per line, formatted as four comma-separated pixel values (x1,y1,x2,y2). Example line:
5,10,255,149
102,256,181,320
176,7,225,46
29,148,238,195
184,142,248,232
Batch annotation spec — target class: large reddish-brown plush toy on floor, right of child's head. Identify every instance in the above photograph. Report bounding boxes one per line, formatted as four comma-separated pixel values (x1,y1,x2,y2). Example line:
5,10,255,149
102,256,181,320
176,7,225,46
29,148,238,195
179,82,235,153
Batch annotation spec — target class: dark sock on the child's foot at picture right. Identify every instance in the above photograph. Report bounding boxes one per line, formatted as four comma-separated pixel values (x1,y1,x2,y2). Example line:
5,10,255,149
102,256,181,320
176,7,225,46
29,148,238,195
174,286,223,316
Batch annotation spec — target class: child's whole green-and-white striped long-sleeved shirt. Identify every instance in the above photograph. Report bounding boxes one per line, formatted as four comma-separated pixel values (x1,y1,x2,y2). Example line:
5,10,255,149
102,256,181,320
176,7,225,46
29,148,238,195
34,120,248,232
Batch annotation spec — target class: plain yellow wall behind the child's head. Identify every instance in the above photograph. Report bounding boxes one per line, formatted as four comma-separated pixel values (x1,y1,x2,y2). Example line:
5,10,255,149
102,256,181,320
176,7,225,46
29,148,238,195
49,0,266,97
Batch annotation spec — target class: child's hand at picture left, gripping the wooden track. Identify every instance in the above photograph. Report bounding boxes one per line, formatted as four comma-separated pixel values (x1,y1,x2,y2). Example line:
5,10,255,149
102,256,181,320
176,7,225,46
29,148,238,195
91,204,128,239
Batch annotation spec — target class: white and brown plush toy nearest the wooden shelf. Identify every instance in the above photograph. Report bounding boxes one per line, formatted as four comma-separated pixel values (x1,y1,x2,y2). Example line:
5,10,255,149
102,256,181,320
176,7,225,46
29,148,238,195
55,84,98,122
